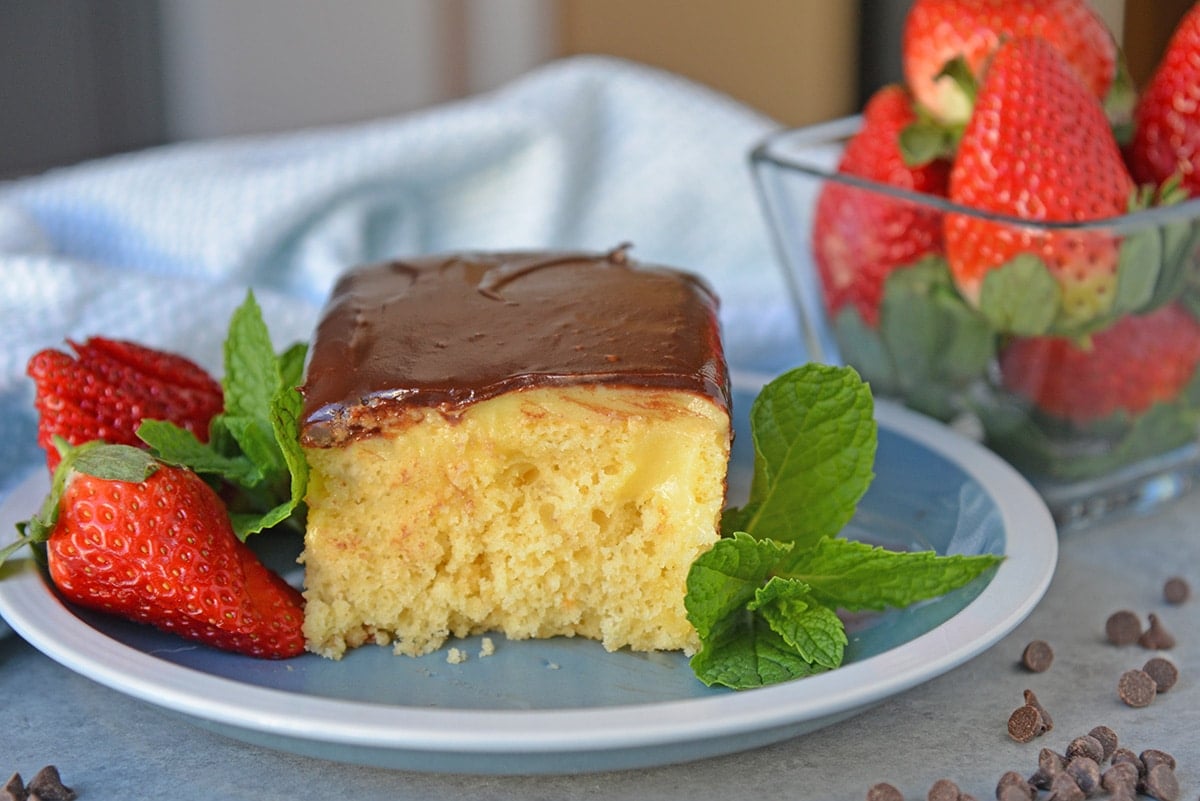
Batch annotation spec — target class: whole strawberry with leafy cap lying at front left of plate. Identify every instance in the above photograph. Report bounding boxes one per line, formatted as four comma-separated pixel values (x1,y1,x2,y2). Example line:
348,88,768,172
0,440,304,658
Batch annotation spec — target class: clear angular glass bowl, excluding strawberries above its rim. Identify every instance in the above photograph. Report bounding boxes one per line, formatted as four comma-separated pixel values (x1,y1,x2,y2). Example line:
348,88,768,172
750,116,1200,529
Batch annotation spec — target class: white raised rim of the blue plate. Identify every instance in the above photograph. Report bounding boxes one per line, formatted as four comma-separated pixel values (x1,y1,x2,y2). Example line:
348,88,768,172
0,390,1058,757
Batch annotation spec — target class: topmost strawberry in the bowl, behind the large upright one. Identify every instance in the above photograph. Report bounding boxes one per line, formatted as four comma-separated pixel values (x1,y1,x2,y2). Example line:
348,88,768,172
901,0,1117,124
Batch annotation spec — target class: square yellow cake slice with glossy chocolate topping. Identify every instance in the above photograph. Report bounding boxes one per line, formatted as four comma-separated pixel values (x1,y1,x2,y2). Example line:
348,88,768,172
301,248,731,658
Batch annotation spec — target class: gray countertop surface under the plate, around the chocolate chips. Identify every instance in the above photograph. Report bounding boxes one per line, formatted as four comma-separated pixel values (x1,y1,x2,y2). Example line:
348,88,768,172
0,482,1200,801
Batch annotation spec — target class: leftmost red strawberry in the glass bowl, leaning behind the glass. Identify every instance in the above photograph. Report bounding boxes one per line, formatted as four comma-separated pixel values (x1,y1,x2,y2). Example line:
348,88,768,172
812,85,949,326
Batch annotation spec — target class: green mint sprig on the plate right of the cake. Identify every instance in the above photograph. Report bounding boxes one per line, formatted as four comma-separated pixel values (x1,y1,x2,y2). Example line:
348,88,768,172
684,365,1001,689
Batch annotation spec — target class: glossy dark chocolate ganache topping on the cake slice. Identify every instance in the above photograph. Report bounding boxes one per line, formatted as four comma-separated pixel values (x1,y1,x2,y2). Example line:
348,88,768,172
301,247,728,447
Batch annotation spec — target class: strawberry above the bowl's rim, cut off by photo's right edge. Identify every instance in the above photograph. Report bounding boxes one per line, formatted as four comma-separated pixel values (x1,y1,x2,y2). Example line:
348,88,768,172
1129,4,1200,195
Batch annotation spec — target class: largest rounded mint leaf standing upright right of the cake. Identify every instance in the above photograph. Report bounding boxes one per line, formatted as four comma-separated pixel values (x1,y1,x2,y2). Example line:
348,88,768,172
722,365,876,544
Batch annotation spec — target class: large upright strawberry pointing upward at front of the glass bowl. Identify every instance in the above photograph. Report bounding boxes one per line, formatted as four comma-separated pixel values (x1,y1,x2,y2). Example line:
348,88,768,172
946,38,1134,323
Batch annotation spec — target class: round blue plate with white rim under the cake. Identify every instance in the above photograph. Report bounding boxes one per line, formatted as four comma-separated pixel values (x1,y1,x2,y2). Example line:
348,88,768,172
0,380,1057,773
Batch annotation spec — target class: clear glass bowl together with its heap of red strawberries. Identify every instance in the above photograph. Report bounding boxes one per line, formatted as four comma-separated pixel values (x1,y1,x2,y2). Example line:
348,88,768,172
750,0,1200,528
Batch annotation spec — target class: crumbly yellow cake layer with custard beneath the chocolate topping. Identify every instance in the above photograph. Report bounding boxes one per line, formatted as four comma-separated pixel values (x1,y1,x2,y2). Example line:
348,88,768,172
301,386,730,658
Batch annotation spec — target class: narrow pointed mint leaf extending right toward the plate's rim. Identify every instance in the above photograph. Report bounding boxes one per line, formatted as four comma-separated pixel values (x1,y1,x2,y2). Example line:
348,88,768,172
779,537,1001,612
